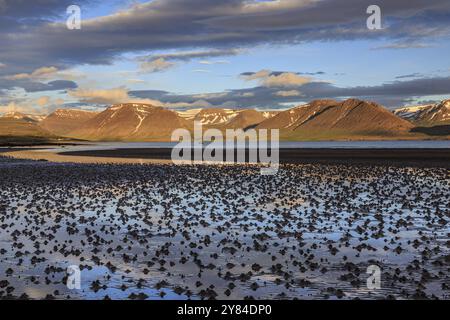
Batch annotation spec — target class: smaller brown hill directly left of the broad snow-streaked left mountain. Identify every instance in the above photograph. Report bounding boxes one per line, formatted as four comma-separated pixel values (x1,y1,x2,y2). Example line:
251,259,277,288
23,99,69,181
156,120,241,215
39,109,98,136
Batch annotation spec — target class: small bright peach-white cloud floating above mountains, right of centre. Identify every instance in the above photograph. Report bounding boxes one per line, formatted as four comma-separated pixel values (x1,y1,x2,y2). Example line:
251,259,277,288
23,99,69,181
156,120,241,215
241,70,311,87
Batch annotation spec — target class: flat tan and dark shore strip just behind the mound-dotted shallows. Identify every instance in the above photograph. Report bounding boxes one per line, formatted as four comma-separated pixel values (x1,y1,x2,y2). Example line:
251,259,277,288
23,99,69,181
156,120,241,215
0,148,450,168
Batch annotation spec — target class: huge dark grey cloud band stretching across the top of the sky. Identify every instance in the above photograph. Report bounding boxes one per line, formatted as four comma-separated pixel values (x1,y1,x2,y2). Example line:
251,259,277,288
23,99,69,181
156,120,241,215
0,0,450,72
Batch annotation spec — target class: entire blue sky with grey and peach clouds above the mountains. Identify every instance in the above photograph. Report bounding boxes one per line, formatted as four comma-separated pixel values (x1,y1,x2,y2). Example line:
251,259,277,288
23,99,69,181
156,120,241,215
0,0,450,114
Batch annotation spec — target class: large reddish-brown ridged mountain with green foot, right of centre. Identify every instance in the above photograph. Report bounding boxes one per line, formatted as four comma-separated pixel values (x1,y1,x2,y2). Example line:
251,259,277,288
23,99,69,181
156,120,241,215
257,99,413,140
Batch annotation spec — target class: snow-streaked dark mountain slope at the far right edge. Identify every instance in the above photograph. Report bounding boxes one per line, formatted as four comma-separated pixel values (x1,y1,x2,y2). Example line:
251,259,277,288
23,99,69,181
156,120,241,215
394,100,450,127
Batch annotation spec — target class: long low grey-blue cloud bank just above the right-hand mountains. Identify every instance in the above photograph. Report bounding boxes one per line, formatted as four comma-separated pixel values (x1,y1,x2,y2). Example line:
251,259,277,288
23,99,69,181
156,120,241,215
130,77,450,109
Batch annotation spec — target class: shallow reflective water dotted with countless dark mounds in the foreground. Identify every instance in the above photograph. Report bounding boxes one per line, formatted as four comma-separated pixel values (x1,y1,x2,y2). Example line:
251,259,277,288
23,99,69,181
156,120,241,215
0,159,450,299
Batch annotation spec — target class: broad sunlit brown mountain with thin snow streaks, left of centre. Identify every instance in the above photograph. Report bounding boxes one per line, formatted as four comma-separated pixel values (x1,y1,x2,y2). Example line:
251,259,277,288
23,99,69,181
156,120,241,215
68,103,191,141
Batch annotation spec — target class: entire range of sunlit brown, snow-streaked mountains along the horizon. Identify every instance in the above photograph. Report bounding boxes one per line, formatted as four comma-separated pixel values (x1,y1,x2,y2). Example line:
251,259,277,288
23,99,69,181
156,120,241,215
0,99,450,141
